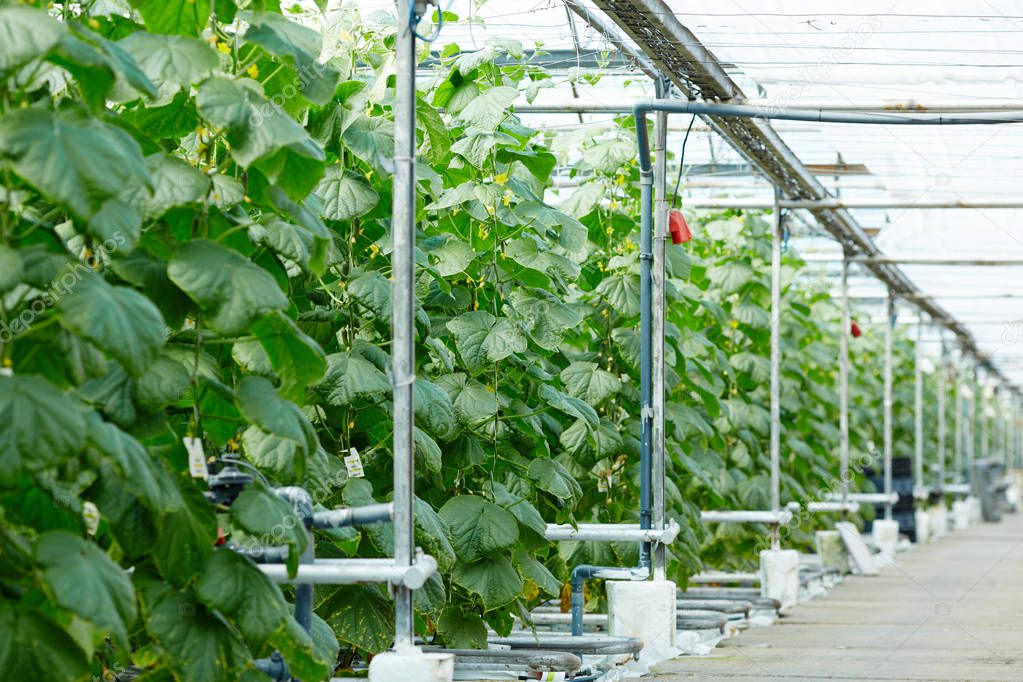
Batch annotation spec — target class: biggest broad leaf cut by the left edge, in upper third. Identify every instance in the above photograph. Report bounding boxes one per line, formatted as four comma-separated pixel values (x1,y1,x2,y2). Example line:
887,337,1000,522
0,108,149,220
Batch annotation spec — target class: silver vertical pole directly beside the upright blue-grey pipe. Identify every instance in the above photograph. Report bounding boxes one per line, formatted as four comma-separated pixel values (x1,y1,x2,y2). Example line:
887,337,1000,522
652,86,668,580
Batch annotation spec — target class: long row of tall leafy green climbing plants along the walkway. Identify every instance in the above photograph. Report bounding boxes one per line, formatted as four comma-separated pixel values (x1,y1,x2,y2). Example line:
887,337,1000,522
0,0,973,682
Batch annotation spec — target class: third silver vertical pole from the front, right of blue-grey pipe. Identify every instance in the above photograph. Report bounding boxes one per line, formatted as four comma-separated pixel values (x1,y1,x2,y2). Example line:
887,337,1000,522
770,187,784,549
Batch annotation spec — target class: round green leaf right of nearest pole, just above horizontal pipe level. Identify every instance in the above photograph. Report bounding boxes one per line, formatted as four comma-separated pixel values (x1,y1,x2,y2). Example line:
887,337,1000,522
438,495,519,562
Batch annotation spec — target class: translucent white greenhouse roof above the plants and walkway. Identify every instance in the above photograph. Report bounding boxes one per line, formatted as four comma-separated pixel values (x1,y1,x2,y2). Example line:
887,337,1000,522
345,0,1023,392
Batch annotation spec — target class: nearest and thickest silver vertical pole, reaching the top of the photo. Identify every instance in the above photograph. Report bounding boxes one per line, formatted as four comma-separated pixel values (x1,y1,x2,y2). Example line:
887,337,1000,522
391,0,415,650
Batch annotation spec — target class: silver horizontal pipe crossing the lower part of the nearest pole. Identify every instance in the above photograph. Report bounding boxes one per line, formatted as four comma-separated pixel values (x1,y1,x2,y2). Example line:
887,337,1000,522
259,555,437,590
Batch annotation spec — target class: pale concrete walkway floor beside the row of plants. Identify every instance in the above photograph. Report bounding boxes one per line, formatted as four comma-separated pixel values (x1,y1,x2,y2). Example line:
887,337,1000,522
654,513,1023,681
